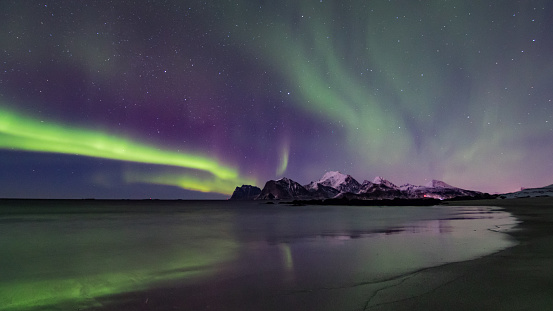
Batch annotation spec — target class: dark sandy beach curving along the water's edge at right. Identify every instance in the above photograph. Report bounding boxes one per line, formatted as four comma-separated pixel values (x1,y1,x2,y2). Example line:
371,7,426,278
365,198,553,310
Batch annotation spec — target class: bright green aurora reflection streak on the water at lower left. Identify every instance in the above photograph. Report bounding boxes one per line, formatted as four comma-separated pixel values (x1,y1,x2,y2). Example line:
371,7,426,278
0,251,233,310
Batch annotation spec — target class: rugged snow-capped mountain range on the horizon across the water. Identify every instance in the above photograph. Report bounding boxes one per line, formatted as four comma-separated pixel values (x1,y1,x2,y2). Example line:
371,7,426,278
231,171,486,200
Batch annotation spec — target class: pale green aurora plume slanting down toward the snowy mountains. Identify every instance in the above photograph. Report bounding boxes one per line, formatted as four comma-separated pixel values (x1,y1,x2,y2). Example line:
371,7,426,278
220,1,414,167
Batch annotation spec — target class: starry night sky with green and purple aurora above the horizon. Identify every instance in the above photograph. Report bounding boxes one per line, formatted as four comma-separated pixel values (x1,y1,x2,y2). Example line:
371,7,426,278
0,0,553,199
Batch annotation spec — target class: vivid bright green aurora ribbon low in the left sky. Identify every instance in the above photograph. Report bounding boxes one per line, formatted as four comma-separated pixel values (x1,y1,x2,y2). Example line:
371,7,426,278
0,107,255,194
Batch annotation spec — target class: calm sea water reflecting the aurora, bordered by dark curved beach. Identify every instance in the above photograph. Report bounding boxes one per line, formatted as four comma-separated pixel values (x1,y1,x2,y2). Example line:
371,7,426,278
0,200,516,310
